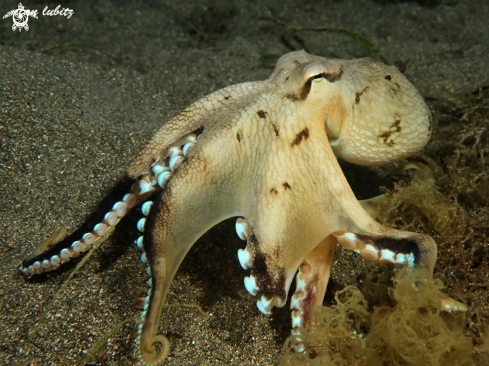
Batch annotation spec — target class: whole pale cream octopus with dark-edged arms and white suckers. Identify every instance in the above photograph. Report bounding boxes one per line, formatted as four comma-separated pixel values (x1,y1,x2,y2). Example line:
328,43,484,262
21,51,437,365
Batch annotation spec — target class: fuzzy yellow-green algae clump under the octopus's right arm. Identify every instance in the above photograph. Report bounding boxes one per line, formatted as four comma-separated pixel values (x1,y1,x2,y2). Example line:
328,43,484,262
280,268,475,366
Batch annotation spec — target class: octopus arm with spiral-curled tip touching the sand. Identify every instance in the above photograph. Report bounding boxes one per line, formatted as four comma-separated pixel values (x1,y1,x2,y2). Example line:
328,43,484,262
133,197,233,365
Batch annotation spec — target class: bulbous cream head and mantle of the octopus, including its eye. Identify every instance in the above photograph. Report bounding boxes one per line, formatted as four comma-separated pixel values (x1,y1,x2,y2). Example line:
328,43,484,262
271,51,432,165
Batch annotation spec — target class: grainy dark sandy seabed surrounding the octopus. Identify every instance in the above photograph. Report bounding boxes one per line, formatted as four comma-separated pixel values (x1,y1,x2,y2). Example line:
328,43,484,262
0,0,489,365
